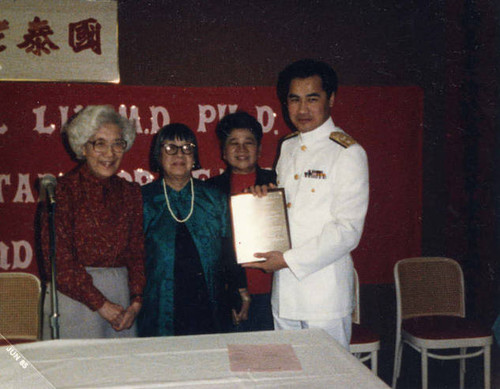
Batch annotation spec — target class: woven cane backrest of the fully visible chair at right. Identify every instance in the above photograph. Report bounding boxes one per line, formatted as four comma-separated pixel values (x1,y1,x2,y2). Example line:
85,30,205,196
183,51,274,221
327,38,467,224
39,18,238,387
394,257,465,321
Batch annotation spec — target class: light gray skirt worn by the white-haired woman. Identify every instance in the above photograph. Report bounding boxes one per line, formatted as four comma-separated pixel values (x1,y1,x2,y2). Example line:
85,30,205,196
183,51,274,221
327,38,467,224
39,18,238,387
42,267,137,340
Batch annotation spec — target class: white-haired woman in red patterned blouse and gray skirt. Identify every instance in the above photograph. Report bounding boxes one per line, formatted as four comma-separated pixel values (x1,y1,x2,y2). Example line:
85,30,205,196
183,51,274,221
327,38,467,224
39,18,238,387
42,106,145,338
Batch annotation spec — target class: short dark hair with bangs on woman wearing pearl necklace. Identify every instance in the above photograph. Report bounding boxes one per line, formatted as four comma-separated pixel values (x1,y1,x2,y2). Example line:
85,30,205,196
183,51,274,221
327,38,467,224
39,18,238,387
151,123,201,173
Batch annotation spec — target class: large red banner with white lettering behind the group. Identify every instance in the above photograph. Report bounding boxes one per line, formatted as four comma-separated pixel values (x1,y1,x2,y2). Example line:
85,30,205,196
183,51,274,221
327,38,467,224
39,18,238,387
0,83,423,283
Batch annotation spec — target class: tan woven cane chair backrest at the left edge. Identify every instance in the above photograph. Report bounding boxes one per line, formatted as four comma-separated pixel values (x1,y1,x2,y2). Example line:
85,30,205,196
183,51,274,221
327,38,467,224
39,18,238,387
0,273,41,340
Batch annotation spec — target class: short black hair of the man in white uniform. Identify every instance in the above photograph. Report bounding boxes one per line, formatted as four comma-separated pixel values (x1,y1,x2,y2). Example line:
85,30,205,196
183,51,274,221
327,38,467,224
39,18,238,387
276,59,339,104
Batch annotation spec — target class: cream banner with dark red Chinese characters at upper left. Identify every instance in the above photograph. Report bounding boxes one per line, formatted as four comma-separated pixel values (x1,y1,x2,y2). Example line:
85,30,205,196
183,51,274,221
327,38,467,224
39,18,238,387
0,0,120,82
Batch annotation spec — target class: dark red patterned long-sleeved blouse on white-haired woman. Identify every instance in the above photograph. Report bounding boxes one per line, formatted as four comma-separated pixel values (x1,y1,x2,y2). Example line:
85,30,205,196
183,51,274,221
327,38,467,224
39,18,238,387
42,164,145,311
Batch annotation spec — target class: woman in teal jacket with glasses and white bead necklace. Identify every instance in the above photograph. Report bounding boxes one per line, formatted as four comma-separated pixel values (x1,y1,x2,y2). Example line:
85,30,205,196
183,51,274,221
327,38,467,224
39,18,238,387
138,124,246,336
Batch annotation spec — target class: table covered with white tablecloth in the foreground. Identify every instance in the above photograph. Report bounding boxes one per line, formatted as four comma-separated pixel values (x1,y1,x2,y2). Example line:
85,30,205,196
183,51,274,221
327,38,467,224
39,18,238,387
0,329,388,389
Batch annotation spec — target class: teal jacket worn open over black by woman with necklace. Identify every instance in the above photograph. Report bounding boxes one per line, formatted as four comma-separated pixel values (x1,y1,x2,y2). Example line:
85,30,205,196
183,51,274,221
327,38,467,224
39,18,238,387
138,179,238,336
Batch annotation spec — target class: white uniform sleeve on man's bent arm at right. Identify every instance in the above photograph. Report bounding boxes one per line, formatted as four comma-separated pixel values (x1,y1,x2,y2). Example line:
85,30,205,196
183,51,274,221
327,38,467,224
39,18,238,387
284,144,369,280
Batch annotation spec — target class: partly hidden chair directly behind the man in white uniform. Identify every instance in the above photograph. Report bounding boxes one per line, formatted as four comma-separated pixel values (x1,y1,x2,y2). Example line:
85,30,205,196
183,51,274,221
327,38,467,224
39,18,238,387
349,270,380,375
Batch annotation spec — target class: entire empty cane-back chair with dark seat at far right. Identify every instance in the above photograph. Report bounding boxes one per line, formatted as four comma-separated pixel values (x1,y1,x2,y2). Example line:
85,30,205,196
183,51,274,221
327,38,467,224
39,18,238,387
392,257,493,389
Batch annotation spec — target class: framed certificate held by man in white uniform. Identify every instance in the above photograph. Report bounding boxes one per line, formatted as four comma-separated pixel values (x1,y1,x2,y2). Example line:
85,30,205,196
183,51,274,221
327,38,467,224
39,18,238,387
230,188,291,263
